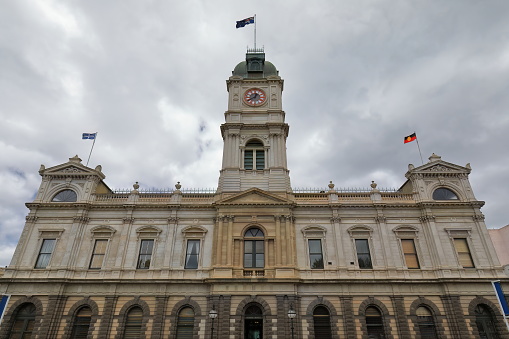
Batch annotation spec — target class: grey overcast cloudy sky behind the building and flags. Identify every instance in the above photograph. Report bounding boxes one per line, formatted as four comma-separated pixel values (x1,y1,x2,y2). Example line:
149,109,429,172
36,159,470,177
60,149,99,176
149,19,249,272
0,0,509,266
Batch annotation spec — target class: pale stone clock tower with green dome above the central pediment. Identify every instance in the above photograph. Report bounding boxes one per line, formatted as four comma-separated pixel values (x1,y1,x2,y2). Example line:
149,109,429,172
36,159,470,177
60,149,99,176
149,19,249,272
218,49,291,193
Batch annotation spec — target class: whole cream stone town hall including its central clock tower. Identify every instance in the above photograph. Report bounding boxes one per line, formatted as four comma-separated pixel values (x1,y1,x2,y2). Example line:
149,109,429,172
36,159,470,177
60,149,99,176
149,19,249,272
0,50,509,339
